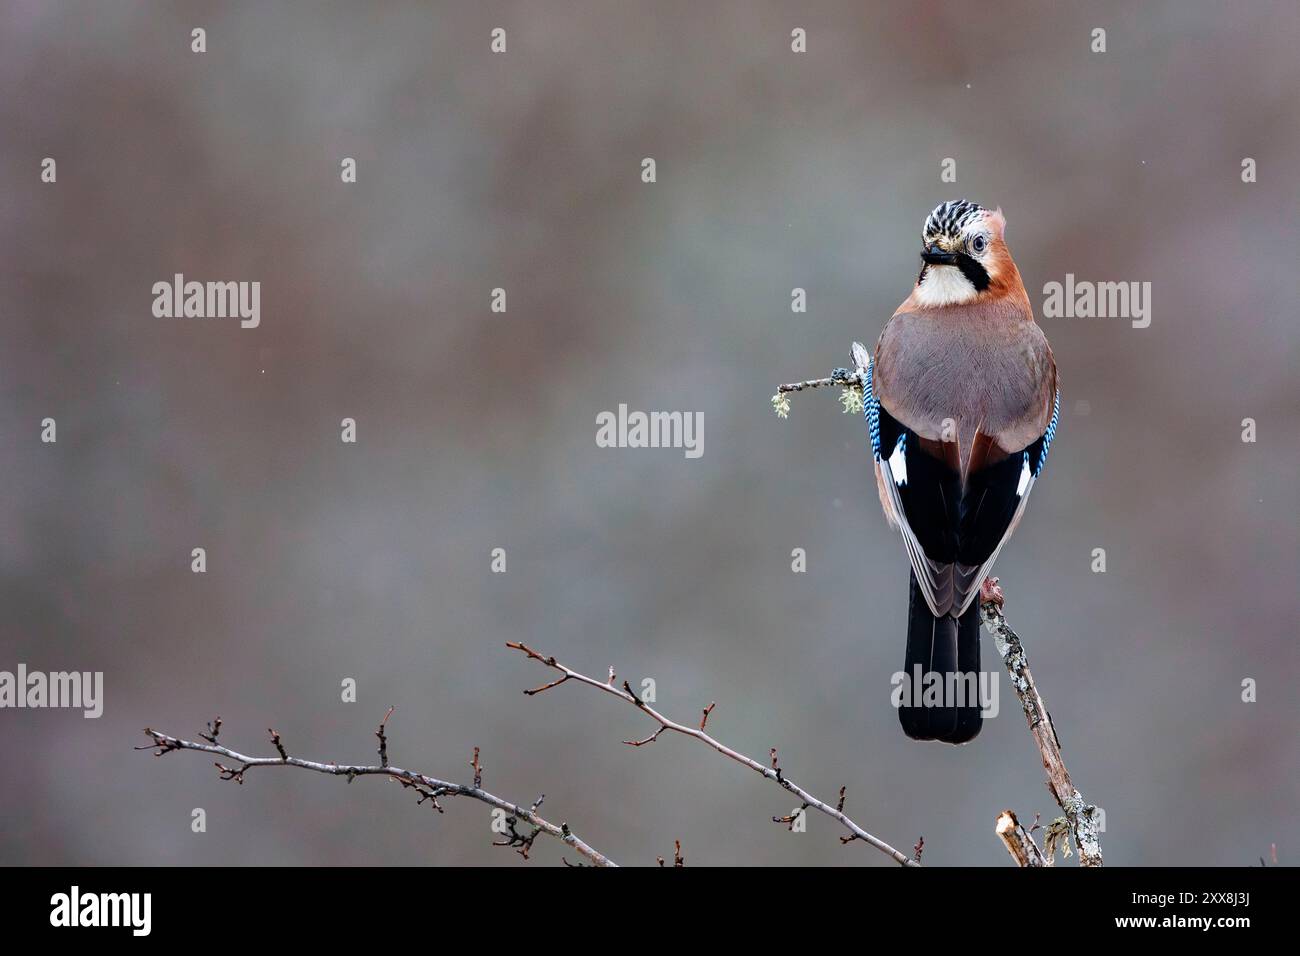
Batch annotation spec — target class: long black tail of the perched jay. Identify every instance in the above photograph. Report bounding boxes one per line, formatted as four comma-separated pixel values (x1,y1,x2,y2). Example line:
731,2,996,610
898,572,984,744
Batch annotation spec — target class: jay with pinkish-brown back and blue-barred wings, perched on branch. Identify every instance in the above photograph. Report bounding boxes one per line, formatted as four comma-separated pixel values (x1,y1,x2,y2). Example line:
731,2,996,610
855,199,1061,744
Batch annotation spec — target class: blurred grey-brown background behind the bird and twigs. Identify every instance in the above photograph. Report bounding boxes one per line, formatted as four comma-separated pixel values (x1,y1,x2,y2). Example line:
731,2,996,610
0,0,1300,866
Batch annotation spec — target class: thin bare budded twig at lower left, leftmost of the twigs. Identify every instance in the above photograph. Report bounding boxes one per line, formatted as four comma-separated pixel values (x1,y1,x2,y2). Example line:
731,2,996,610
135,708,616,866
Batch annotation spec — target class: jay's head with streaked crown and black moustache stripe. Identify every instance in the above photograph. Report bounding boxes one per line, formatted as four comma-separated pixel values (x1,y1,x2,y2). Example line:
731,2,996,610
913,199,1023,307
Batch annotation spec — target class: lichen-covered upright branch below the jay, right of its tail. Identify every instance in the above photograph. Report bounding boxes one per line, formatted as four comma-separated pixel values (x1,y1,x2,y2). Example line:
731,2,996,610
980,578,1101,866
